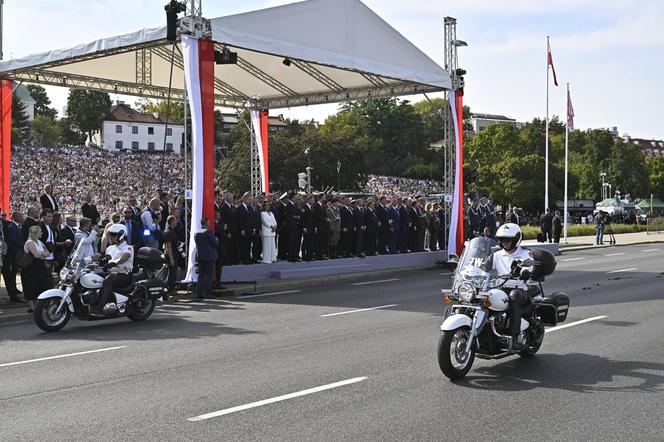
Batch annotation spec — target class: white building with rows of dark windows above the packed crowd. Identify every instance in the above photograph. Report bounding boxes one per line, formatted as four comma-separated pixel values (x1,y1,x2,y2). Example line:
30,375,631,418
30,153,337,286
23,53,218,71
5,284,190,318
92,103,184,155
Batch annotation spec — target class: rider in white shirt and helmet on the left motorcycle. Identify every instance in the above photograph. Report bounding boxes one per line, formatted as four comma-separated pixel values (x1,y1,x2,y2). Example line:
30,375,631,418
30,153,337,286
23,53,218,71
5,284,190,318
96,224,134,313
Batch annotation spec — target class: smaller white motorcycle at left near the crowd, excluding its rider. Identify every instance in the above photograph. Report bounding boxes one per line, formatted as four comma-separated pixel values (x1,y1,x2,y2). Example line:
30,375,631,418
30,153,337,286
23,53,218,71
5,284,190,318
33,235,167,332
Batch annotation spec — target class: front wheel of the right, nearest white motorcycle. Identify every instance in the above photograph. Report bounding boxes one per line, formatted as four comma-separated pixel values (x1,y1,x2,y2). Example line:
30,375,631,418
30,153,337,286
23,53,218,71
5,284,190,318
438,327,475,380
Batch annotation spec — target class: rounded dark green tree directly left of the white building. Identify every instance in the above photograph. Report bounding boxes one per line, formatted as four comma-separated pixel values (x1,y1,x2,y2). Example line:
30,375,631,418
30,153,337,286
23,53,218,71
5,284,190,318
67,89,111,143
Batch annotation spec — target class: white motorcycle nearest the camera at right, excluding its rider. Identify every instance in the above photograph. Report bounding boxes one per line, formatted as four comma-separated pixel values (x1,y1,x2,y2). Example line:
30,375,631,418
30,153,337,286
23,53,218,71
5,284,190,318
438,237,569,380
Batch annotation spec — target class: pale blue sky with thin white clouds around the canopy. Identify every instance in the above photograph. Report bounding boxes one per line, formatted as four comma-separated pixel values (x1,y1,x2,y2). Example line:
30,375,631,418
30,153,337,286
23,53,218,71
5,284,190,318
3,0,664,139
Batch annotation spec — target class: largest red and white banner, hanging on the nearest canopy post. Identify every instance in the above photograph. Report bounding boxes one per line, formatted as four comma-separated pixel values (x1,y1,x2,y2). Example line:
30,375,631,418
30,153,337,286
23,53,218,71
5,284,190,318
182,35,215,281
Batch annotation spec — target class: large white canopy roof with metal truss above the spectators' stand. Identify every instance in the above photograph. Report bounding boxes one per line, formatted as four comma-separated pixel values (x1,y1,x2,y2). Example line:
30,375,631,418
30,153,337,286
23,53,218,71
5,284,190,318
0,0,451,109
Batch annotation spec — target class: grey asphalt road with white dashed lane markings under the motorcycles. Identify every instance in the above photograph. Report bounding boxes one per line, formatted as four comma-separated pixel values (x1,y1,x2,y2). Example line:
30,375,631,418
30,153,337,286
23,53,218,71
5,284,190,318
0,244,664,442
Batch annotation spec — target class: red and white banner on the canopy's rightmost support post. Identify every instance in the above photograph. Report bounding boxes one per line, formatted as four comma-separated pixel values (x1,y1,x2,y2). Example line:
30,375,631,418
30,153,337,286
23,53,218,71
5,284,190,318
447,90,464,256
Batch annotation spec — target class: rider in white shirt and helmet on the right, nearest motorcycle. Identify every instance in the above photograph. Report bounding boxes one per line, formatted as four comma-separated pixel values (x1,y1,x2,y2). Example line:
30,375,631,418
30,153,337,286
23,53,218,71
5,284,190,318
483,223,533,345
